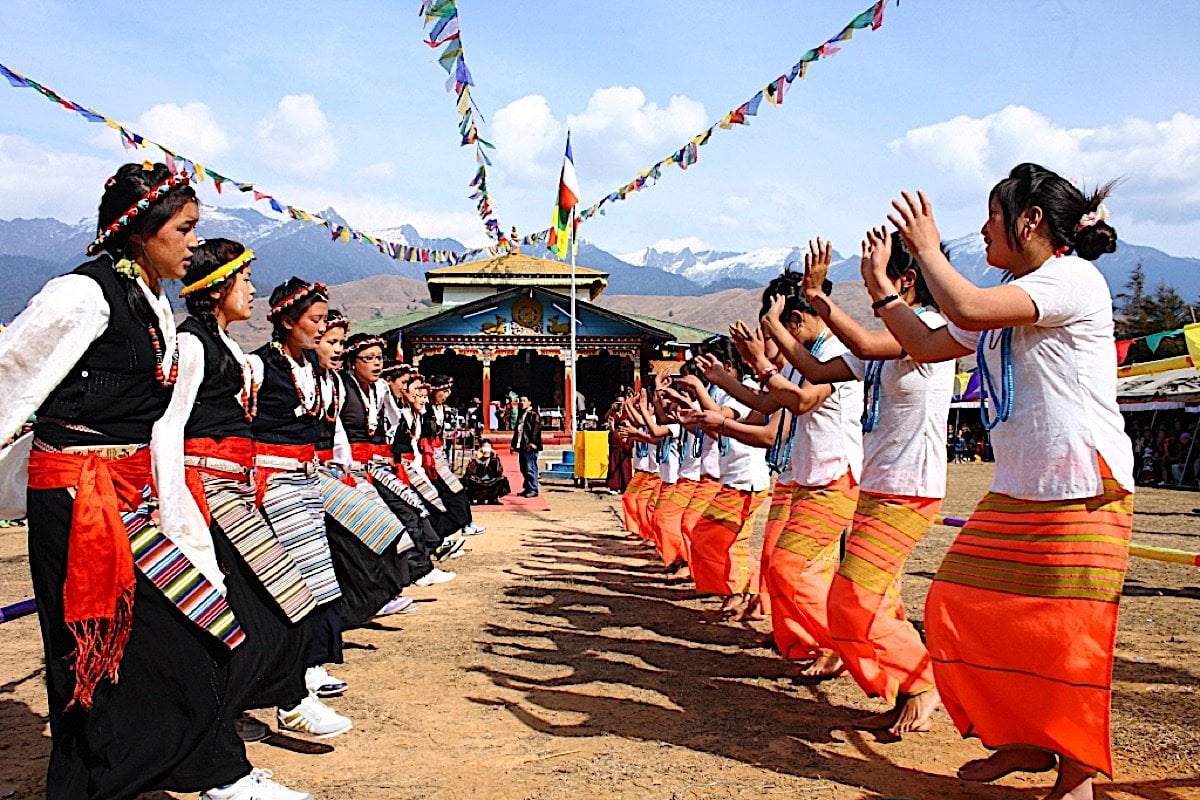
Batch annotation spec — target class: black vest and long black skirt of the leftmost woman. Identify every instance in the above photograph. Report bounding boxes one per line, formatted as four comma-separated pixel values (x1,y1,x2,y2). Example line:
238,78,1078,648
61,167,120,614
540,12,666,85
28,257,256,800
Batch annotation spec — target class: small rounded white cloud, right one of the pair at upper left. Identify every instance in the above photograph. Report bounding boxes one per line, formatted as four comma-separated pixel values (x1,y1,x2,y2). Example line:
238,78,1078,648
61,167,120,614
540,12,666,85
254,95,337,175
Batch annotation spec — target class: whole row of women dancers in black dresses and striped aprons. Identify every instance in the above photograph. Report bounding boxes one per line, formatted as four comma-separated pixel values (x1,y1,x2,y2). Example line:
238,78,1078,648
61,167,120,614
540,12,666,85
0,164,482,800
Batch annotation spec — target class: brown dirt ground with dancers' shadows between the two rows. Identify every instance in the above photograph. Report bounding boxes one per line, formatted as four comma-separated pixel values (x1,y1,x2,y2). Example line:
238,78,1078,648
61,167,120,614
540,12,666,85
0,464,1200,800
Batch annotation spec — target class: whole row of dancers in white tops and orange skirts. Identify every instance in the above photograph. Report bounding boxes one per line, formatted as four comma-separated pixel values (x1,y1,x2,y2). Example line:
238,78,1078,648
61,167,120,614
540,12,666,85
622,163,1134,800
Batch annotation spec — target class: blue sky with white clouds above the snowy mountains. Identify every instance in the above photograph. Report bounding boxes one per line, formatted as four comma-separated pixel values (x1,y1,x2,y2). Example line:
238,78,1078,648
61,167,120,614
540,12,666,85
0,0,1200,257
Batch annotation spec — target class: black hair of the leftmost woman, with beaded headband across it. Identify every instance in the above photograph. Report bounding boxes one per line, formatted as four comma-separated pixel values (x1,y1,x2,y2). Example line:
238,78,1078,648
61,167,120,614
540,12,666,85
96,163,199,259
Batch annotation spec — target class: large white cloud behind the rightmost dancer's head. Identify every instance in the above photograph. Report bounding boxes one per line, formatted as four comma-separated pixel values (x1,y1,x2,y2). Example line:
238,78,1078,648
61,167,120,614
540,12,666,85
888,106,1200,224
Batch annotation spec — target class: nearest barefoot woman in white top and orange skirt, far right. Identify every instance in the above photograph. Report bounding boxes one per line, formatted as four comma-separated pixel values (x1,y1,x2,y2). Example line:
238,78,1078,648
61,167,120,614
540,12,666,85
868,163,1134,800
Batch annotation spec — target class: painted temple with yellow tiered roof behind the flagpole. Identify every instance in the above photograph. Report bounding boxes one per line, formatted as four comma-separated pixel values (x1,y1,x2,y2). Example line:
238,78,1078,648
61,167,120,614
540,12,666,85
355,252,710,429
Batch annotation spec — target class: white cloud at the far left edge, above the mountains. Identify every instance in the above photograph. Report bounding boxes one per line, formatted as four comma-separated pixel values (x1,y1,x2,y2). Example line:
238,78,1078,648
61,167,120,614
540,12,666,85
0,134,115,221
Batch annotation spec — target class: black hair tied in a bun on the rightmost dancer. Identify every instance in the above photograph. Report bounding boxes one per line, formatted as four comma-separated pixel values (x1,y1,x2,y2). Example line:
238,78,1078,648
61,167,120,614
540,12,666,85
988,162,1117,261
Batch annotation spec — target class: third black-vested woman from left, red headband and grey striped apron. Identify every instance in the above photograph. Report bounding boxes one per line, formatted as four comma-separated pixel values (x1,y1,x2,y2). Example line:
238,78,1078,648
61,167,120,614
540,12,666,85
251,278,352,736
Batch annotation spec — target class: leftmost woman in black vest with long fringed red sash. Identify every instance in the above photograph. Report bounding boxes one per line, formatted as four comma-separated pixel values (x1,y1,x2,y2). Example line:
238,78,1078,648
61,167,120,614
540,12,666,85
0,164,300,800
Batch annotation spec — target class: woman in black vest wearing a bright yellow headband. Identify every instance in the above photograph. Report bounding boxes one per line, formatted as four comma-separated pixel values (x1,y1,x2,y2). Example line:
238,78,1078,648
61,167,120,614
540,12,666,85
152,239,316,786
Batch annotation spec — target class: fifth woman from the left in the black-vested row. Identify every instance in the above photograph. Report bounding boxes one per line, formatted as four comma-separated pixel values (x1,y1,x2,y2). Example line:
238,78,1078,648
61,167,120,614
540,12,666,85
317,326,413,627
